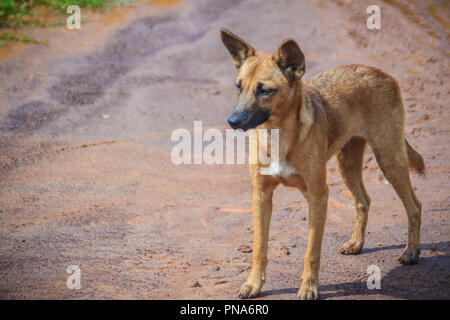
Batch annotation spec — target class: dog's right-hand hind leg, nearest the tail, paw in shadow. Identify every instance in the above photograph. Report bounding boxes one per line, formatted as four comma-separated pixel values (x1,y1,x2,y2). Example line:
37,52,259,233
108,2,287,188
370,135,422,264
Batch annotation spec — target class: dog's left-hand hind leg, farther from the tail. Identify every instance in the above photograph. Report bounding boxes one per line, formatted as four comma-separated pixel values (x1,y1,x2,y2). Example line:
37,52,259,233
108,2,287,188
336,137,370,254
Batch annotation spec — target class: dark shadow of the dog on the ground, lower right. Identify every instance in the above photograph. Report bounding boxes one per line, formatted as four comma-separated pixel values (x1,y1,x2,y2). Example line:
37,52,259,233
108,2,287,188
261,242,450,300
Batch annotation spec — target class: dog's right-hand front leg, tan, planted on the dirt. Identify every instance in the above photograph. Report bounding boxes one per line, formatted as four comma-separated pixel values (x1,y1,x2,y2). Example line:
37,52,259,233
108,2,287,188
298,183,328,300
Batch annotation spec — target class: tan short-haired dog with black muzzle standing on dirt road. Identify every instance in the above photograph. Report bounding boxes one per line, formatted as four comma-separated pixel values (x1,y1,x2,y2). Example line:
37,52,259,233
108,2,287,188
221,29,425,299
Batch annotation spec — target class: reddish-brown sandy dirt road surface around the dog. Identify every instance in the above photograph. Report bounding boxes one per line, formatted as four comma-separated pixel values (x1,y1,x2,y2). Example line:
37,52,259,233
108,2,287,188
0,0,450,299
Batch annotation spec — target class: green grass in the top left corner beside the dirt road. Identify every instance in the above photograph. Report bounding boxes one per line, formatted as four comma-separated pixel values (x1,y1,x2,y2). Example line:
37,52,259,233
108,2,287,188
0,0,121,47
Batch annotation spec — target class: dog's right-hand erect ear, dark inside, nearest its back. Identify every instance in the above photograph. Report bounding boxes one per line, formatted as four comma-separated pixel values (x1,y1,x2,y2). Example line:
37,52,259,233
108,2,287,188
273,39,305,82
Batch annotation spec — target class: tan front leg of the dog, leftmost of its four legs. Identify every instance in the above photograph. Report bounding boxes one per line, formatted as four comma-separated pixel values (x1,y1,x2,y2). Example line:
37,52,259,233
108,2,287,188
238,175,277,299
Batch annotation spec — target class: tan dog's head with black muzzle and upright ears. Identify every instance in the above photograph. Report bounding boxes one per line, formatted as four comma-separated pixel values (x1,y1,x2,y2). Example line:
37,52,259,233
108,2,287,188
221,29,305,131
